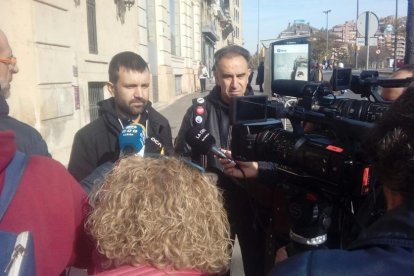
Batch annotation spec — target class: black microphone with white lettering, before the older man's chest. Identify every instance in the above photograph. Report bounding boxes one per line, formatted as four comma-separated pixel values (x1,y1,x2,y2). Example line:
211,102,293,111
185,126,228,161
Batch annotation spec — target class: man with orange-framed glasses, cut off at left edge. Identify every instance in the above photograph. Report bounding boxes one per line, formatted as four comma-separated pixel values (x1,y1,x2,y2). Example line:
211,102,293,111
0,30,50,156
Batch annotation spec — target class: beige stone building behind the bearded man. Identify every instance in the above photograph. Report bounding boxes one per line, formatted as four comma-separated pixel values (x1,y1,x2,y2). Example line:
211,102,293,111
0,0,242,164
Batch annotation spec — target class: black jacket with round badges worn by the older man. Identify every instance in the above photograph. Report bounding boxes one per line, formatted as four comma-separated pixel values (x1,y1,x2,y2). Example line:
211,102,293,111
174,86,268,276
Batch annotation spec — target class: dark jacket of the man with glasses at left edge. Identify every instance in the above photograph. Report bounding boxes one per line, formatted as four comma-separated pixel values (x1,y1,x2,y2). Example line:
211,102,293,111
0,95,50,156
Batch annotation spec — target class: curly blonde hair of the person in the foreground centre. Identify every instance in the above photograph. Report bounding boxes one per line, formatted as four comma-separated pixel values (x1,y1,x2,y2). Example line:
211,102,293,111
86,156,232,274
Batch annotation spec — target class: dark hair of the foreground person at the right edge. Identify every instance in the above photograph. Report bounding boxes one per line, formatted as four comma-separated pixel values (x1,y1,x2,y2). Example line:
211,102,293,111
365,85,414,200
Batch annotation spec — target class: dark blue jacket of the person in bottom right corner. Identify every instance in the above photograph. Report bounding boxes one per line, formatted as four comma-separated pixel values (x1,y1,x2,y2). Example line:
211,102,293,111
269,202,414,276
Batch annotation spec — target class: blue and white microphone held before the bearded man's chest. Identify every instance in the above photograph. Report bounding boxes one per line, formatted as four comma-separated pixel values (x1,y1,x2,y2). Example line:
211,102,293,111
118,124,146,156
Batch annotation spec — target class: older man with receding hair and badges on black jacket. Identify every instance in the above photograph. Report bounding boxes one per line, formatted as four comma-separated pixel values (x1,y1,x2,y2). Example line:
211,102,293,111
174,45,265,276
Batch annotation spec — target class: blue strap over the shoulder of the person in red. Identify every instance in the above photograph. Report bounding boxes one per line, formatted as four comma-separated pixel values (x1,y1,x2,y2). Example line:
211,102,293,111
0,151,27,220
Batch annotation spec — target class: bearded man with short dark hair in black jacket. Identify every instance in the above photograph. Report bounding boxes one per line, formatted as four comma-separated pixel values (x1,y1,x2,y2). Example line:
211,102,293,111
68,52,173,190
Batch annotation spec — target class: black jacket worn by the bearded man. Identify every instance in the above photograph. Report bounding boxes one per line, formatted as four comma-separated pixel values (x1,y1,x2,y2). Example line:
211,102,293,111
68,98,174,181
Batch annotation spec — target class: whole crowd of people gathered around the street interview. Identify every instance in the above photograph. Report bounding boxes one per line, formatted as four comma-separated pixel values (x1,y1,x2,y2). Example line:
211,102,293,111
0,24,414,276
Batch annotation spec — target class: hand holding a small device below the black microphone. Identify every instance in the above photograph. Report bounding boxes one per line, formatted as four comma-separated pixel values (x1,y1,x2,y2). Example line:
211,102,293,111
219,150,259,178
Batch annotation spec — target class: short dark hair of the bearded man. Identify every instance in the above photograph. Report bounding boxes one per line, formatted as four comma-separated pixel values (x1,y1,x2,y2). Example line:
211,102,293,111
108,51,149,83
